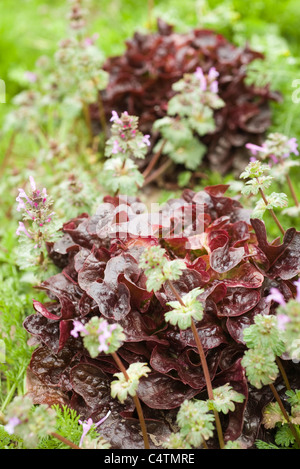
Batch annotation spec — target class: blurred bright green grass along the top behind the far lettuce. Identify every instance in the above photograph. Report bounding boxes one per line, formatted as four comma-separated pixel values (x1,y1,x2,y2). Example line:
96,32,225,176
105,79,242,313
0,0,300,139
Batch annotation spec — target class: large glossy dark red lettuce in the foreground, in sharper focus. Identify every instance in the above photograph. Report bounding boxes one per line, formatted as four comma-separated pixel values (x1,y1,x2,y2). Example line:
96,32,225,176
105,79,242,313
24,185,300,448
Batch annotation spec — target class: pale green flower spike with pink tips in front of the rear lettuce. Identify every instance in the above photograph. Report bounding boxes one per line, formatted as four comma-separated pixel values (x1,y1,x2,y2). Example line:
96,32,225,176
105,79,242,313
153,67,225,170
